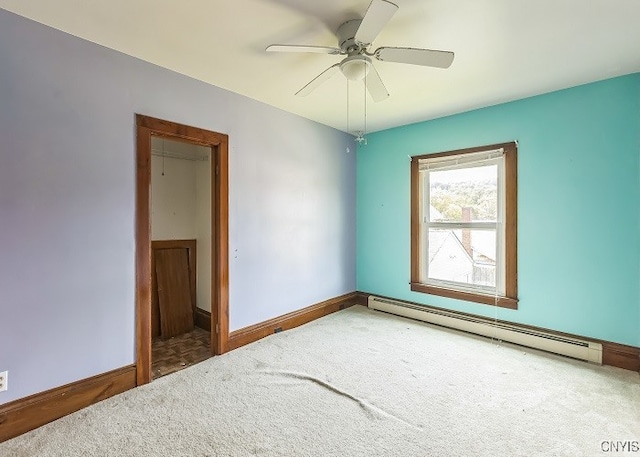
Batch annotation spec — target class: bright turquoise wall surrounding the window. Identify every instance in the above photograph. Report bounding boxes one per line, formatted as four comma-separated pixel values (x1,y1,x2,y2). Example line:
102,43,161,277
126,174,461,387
357,74,640,346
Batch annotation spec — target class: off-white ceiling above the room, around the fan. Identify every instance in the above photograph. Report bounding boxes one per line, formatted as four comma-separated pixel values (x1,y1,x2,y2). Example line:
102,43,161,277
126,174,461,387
0,0,640,131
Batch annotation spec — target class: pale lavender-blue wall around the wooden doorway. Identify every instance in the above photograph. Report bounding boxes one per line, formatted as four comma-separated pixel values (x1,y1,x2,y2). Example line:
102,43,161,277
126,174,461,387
0,10,356,404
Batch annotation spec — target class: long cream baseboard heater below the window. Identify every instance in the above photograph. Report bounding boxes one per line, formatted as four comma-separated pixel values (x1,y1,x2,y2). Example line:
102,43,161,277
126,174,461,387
368,295,602,364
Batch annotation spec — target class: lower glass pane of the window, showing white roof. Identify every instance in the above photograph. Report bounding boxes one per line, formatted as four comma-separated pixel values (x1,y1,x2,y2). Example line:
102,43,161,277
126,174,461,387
429,228,496,287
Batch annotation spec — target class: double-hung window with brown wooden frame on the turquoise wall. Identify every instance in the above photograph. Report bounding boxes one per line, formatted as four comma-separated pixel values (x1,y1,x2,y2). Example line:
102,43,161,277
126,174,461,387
411,143,518,309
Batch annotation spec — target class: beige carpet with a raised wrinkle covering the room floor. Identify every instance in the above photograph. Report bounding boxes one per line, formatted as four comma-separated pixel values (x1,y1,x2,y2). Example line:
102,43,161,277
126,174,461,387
0,306,640,457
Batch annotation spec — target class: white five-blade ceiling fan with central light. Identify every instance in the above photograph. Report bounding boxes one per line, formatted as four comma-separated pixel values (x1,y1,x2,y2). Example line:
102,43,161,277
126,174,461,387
266,0,454,102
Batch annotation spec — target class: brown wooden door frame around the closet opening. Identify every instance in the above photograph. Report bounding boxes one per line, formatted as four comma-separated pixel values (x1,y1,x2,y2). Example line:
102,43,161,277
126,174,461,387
135,114,229,385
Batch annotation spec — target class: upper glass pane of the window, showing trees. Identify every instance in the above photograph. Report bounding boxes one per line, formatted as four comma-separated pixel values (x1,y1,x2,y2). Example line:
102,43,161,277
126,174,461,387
429,165,498,222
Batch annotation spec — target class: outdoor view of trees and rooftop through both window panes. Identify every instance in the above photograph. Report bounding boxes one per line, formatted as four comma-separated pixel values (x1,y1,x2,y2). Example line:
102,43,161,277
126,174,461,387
428,165,498,287
